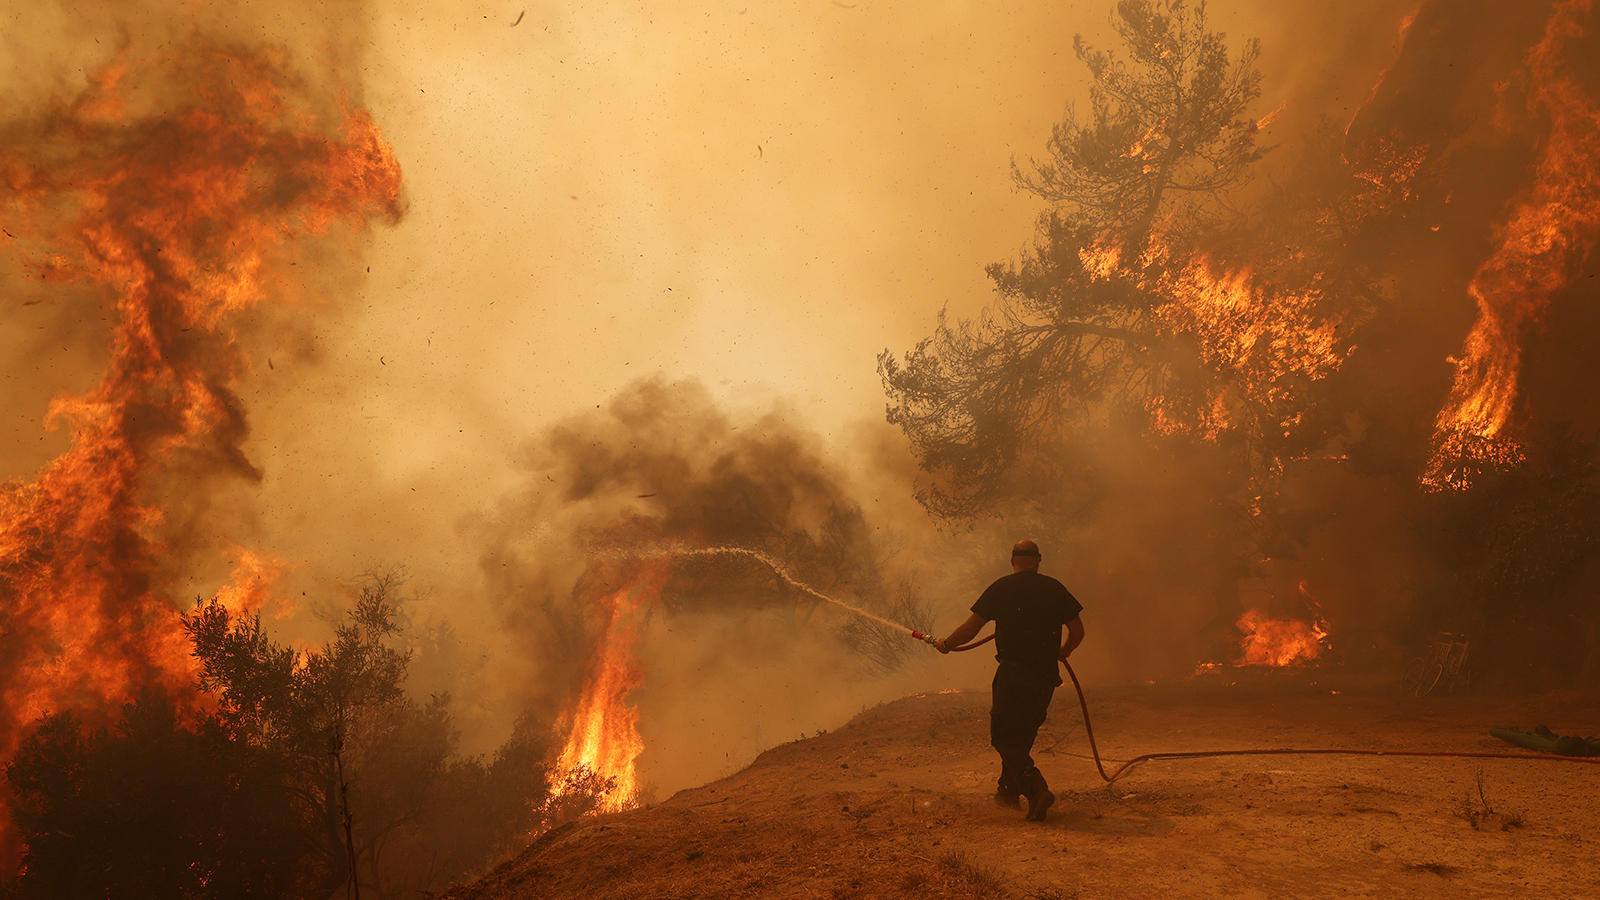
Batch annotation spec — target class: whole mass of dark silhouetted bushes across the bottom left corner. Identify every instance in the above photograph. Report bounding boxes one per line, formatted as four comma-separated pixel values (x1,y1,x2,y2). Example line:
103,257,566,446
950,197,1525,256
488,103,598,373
6,572,550,900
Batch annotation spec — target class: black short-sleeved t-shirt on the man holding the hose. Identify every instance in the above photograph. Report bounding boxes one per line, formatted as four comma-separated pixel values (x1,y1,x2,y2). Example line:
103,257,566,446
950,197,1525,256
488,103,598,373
973,572,1083,684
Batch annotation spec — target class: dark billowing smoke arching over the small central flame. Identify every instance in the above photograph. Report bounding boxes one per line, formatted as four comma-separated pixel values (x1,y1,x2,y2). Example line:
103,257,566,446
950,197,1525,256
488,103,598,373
483,376,925,703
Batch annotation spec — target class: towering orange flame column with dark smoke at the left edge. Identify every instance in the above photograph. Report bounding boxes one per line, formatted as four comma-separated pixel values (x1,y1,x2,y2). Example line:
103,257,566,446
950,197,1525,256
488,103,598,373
0,42,400,855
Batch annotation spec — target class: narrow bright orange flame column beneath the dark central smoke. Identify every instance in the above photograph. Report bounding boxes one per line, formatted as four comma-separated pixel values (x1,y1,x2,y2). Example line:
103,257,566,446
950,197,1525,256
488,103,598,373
555,562,667,812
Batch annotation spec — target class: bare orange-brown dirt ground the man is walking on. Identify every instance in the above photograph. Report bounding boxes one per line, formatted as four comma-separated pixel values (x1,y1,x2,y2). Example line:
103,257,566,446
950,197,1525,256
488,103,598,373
445,669,1600,900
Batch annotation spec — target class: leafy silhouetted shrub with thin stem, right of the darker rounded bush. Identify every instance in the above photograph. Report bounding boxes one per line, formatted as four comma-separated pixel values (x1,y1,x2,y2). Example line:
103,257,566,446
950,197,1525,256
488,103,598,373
186,572,547,898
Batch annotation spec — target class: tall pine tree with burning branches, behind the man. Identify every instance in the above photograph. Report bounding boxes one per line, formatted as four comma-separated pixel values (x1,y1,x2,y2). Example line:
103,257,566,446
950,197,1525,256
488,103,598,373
878,0,1360,528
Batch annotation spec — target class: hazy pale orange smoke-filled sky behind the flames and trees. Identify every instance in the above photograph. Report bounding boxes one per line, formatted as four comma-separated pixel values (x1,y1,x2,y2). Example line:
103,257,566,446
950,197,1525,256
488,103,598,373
0,0,1413,784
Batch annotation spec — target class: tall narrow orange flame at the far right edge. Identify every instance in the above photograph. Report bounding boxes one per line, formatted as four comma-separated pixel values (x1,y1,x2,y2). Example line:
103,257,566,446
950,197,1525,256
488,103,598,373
1422,0,1600,490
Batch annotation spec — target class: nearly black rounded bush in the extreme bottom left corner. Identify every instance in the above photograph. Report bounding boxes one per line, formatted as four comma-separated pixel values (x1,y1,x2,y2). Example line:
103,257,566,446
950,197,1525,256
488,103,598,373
6,690,328,900
